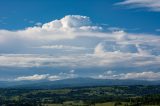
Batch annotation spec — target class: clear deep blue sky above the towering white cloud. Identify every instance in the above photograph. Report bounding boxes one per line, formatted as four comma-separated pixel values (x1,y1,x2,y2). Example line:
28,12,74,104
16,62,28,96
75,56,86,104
0,0,160,33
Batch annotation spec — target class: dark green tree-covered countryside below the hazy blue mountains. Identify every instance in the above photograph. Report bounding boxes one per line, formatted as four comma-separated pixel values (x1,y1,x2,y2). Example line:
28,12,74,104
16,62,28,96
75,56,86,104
0,86,160,106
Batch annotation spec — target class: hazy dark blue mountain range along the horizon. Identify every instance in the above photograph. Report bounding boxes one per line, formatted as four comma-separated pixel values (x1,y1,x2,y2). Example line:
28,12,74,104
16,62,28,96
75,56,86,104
0,78,160,89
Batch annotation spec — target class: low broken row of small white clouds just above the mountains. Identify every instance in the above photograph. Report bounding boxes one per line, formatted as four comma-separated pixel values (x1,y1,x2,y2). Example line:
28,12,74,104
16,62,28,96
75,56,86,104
15,71,160,81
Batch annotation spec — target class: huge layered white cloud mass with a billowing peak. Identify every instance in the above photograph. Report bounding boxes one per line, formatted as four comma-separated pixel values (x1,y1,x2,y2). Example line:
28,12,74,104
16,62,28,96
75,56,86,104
0,15,160,79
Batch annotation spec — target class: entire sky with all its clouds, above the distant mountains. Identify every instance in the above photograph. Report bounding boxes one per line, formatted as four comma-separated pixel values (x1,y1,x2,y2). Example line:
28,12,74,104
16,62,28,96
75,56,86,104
0,0,160,81
